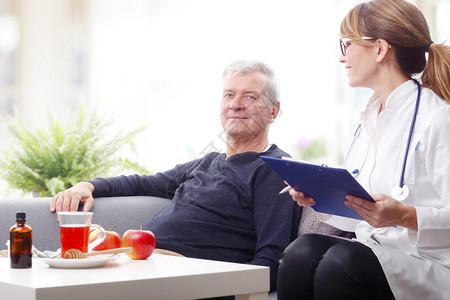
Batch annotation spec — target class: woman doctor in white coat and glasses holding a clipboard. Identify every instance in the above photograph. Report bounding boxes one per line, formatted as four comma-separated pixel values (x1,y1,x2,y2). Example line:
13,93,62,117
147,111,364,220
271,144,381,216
278,0,450,300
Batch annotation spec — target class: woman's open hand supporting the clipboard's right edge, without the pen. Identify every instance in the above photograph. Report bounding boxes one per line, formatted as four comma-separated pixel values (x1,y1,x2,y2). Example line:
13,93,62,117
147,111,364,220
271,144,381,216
345,194,417,231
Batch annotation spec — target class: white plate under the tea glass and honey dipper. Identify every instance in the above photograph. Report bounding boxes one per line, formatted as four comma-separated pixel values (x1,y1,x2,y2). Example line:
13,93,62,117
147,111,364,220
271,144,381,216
39,254,117,269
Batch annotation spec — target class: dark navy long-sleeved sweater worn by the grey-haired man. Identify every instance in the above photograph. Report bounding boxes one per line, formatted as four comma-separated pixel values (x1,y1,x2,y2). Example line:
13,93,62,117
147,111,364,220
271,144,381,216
91,145,301,290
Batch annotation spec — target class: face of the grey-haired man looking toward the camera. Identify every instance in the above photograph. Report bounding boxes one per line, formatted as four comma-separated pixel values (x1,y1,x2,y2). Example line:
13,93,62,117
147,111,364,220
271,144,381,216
220,72,278,140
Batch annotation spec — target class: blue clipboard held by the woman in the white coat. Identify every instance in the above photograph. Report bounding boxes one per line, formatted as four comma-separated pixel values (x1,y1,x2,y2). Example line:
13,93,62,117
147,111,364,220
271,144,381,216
261,156,375,220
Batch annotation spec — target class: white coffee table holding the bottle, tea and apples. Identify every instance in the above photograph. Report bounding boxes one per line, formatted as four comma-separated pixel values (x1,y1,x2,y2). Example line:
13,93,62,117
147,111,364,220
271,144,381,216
0,254,269,300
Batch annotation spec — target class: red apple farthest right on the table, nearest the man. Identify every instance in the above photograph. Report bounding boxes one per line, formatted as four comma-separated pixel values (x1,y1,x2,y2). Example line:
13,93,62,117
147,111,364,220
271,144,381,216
122,229,156,259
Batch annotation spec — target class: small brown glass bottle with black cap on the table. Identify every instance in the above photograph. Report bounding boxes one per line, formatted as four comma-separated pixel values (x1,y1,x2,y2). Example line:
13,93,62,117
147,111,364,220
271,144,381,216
9,211,32,269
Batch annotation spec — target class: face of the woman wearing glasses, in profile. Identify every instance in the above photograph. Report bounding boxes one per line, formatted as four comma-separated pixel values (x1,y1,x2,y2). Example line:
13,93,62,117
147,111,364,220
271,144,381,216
339,42,378,88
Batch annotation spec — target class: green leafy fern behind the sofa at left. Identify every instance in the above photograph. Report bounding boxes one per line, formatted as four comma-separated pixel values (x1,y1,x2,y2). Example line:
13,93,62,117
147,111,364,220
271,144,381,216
0,106,148,197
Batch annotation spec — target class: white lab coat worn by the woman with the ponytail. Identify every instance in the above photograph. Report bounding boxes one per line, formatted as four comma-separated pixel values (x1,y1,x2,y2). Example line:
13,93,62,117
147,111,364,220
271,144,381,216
326,80,450,300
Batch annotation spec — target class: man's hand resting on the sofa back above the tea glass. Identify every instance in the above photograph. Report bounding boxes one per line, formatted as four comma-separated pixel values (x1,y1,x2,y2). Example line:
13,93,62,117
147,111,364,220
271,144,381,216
50,182,94,212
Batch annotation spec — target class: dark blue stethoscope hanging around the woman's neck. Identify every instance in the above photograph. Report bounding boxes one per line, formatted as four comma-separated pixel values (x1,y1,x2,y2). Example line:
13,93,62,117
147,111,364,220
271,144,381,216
347,80,421,201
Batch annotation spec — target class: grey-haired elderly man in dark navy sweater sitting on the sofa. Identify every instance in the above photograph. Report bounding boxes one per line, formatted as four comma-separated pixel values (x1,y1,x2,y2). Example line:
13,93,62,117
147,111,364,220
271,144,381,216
50,61,300,290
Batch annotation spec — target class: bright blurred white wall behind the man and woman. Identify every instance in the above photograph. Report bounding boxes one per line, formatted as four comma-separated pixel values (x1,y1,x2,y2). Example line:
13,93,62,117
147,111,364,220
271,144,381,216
0,0,450,197
